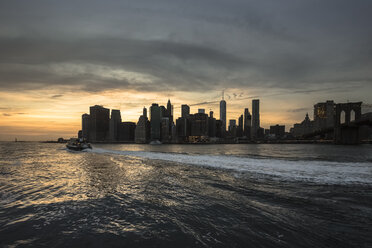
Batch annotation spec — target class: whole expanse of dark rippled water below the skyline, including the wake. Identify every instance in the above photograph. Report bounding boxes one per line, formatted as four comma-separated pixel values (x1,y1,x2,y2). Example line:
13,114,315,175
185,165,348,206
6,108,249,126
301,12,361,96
0,142,372,247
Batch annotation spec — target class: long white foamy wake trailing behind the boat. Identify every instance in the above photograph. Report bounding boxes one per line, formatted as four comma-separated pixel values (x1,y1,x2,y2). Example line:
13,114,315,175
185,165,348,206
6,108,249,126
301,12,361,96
89,148,372,184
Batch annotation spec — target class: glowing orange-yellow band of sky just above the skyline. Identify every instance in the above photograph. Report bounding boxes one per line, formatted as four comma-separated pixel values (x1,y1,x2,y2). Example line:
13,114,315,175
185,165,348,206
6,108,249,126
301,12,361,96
0,86,370,140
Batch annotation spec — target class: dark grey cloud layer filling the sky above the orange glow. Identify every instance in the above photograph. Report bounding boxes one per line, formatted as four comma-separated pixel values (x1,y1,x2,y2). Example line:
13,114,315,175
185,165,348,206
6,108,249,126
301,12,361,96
0,0,372,93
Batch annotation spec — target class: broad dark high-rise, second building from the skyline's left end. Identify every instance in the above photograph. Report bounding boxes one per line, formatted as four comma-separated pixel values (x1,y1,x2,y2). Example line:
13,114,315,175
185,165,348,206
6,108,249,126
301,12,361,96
89,105,110,142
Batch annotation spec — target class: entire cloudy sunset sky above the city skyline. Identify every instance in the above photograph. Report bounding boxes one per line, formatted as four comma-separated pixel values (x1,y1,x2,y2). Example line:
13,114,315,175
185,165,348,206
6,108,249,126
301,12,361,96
0,0,372,140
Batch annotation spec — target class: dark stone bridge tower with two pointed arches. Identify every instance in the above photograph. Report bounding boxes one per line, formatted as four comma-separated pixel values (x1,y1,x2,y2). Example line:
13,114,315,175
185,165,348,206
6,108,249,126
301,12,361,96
333,102,362,145
